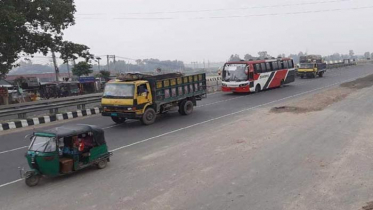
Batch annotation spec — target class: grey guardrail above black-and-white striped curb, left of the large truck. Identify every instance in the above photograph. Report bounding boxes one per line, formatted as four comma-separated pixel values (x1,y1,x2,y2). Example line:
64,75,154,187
0,93,102,119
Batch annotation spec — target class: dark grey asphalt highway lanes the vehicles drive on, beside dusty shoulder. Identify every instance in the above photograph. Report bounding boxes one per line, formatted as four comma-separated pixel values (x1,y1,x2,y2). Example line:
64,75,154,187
0,65,373,209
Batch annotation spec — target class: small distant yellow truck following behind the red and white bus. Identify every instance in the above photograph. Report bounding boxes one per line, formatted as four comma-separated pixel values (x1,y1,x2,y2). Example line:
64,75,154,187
298,55,326,78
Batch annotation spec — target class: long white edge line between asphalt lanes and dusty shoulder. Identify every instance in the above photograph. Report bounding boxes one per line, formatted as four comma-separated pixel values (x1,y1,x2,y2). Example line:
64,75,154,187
0,74,370,188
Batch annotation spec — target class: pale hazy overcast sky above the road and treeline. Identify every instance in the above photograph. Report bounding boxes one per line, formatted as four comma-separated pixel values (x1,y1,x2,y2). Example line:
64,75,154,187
61,0,373,63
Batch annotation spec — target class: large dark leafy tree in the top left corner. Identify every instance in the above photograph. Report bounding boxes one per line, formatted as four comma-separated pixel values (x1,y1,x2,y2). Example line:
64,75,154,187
0,0,88,77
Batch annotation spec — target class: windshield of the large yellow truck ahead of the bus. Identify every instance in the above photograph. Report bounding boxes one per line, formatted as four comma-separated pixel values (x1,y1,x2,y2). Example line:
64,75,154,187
103,83,135,98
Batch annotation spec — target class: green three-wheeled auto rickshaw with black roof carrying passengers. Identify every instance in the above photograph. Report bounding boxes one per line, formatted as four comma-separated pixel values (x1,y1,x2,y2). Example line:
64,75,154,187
22,125,112,187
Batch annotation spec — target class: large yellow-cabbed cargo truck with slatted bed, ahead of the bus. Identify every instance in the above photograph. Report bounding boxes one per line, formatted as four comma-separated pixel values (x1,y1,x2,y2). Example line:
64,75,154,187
101,73,206,125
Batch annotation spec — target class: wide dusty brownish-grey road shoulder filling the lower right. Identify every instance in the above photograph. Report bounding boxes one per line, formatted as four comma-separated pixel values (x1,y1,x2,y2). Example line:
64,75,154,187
0,66,373,210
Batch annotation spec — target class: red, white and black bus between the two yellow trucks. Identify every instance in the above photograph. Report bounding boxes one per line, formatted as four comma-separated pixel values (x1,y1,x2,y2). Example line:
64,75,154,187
222,58,295,93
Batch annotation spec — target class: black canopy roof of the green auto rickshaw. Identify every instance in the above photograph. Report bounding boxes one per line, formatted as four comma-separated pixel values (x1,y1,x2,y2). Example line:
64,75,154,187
34,125,106,146
